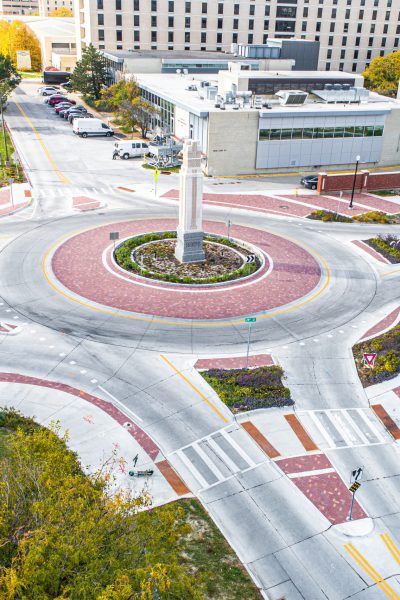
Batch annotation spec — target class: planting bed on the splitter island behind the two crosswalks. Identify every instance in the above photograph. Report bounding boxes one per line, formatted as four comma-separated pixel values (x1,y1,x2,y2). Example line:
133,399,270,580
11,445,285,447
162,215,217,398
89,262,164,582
201,365,294,413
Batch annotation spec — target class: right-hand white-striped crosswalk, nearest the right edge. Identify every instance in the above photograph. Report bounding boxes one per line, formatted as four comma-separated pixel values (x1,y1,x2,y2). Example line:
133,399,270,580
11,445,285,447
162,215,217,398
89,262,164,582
296,408,391,450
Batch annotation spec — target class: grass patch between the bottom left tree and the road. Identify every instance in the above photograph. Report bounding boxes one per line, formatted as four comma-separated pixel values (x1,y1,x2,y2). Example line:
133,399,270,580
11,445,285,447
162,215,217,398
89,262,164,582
178,499,261,600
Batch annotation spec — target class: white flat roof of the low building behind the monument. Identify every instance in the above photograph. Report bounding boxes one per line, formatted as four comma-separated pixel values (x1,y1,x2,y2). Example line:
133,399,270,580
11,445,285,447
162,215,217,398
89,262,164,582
137,71,394,117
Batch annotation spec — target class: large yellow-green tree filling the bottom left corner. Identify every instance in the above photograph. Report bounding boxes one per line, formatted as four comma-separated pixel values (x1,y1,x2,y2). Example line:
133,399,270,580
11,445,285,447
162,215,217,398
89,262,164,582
0,414,203,600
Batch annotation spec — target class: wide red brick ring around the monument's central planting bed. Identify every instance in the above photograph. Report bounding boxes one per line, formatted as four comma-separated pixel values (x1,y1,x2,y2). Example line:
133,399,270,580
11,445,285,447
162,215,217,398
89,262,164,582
52,219,321,319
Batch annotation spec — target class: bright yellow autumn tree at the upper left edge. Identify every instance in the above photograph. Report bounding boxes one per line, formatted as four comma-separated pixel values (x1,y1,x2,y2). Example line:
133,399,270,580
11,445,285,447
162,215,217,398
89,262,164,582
0,20,42,71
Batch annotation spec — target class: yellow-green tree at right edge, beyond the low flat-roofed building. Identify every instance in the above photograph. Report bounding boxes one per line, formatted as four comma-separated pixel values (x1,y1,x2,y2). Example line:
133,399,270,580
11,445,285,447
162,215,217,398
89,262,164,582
363,50,400,98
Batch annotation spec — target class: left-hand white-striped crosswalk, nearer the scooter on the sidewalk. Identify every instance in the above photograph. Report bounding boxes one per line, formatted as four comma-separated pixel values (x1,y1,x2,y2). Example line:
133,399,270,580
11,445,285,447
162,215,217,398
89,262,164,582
168,425,266,493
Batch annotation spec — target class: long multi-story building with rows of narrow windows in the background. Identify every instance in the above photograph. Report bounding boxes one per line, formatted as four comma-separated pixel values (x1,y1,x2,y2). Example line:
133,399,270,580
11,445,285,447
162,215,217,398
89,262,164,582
74,0,400,72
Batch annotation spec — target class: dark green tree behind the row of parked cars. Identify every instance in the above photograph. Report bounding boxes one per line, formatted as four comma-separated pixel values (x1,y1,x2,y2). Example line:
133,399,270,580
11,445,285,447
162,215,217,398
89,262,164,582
70,44,108,100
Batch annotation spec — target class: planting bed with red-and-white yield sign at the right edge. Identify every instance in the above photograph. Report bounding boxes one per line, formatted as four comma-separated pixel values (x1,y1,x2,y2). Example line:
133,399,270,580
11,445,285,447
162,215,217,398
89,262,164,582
353,325,400,387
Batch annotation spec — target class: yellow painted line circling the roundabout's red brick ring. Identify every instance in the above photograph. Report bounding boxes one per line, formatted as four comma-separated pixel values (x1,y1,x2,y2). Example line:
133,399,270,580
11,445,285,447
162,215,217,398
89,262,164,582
42,218,331,328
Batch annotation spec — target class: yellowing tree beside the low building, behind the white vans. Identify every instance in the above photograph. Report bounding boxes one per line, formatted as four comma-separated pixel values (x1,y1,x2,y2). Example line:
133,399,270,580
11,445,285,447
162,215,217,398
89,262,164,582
101,79,158,138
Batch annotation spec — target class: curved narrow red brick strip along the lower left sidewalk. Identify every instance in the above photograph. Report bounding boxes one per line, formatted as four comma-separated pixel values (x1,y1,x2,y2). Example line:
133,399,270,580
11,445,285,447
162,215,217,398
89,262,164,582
0,373,160,461
